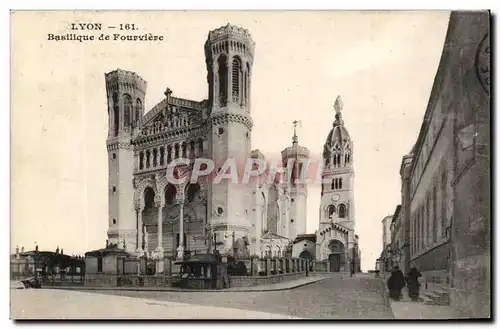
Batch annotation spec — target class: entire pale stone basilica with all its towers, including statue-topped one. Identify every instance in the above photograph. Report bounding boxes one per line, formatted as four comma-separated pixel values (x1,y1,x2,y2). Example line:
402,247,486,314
105,24,355,267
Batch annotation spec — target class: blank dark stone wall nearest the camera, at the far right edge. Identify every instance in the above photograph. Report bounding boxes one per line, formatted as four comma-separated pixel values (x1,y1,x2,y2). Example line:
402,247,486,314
444,12,491,317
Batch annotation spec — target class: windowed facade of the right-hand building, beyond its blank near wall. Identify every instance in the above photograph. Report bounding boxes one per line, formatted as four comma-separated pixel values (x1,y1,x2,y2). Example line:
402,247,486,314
409,8,454,288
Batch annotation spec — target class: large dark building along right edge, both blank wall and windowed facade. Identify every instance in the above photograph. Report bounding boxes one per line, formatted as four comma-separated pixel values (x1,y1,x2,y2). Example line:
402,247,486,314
400,12,491,317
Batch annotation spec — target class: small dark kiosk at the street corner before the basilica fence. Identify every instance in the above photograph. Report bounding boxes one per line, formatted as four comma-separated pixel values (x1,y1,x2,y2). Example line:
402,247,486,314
173,254,229,290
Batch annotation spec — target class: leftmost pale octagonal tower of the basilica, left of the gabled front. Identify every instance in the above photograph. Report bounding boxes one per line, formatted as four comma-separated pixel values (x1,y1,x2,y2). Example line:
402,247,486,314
105,69,146,251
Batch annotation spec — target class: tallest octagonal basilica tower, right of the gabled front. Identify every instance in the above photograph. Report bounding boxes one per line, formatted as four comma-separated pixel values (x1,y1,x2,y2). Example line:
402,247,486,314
205,24,255,254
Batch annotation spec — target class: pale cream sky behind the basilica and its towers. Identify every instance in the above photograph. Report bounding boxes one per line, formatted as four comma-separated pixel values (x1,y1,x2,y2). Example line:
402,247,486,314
11,11,449,270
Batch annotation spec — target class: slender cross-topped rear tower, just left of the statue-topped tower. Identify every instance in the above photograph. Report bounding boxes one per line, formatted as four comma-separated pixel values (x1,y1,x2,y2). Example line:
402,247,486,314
281,121,310,240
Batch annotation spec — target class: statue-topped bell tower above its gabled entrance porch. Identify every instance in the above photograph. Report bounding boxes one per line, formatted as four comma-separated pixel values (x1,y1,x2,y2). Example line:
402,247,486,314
319,96,355,236
